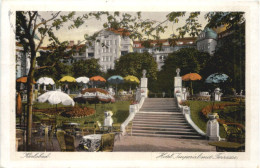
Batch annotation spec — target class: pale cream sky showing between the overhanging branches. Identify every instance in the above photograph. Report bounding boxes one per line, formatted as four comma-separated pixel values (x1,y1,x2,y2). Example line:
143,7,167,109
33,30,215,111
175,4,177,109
40,11,207,46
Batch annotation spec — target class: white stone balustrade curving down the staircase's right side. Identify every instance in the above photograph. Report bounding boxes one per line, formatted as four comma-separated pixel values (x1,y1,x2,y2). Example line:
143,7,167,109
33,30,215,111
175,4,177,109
176,93,206,136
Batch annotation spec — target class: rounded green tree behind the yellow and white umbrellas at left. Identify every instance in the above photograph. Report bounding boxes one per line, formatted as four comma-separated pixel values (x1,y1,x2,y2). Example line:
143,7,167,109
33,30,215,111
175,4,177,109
72,58,101,77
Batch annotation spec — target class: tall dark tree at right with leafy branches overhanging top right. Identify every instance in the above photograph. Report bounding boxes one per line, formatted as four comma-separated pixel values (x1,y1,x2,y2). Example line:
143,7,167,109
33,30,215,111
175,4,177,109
167,12,245,93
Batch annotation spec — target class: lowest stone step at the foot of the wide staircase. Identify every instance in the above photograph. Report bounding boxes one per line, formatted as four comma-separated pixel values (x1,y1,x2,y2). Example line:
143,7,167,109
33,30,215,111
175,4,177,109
132,133,204,139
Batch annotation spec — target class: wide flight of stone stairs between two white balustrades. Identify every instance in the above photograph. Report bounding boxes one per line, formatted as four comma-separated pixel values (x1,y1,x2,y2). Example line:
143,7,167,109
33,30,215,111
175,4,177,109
132,98,203,139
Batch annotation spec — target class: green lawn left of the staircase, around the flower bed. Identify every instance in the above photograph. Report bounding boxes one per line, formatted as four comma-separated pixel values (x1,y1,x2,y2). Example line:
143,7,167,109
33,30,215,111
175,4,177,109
21,101,130,126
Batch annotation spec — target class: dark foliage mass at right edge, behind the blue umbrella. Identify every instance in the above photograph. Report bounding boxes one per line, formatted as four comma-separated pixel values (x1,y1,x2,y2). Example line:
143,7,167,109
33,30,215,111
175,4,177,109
202,24,245,93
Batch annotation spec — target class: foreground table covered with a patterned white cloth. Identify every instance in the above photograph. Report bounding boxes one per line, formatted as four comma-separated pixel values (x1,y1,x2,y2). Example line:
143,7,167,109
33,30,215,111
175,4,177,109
79,134,102,152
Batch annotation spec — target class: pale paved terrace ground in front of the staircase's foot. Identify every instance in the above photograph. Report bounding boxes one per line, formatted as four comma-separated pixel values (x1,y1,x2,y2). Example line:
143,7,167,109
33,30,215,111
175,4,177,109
114,136,216,152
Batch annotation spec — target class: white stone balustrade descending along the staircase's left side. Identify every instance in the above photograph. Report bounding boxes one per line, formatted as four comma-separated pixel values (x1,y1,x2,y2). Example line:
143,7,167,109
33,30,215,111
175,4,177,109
120,97,145,135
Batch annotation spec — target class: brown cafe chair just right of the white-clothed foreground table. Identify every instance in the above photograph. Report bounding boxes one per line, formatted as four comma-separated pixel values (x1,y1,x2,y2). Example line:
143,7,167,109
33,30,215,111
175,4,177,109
99,133,115,152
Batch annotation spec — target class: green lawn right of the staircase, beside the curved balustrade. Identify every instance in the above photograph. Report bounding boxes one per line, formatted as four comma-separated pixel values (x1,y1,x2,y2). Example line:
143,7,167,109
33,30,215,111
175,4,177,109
187,101,233,138
